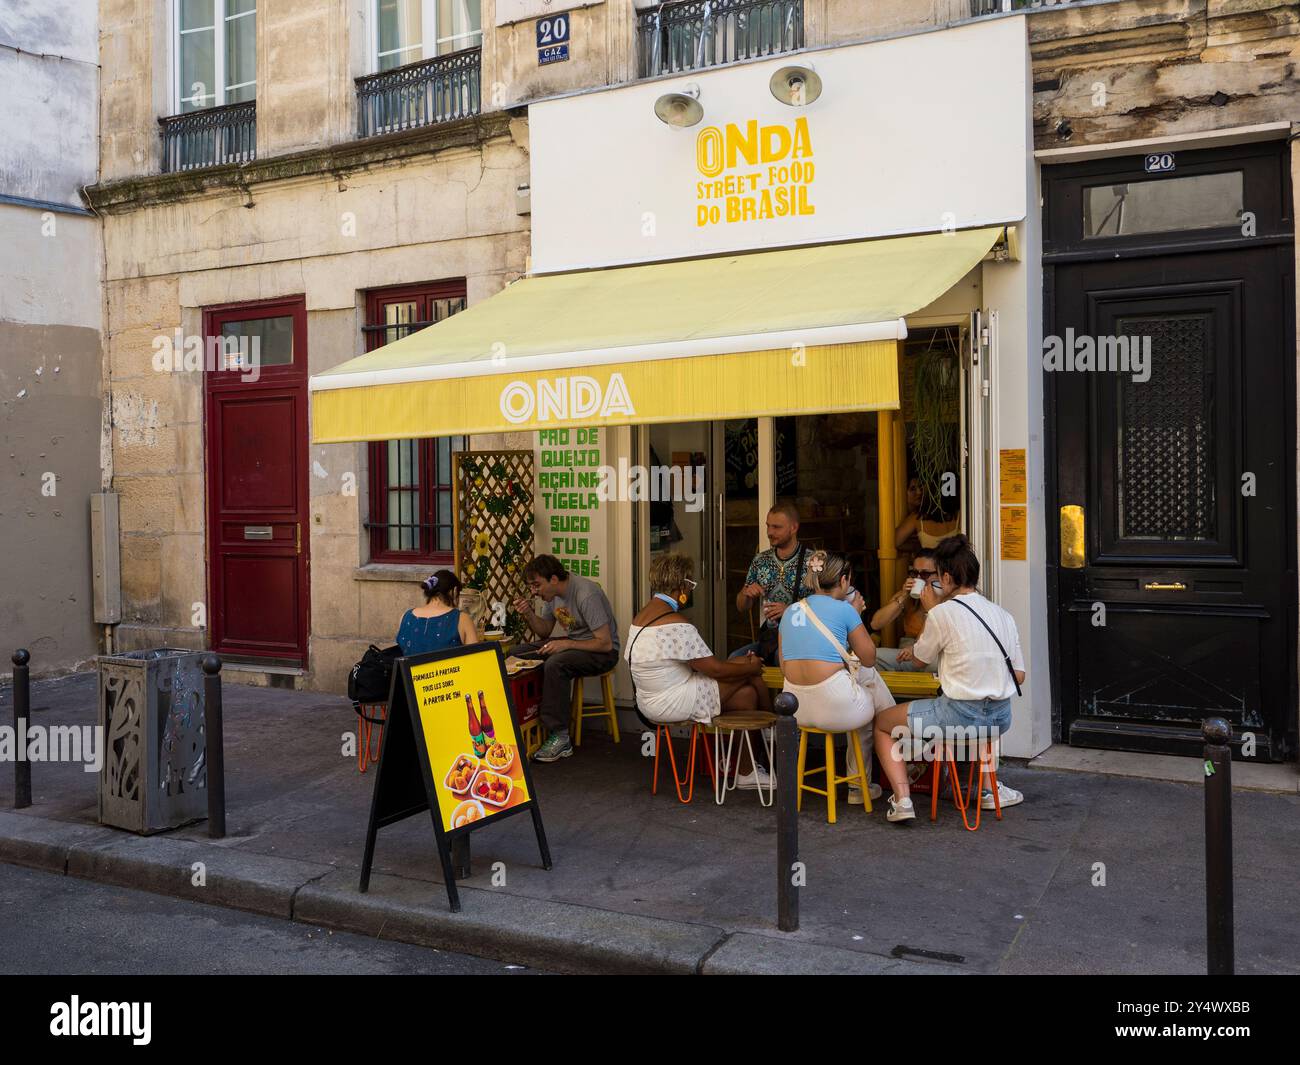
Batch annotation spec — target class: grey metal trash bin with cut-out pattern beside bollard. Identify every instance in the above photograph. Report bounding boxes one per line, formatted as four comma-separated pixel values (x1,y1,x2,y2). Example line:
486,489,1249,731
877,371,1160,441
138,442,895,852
95,648,208,835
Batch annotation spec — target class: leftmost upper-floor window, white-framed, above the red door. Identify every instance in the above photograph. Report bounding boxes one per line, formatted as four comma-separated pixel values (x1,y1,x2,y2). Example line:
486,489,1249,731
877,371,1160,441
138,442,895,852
173,0,257,113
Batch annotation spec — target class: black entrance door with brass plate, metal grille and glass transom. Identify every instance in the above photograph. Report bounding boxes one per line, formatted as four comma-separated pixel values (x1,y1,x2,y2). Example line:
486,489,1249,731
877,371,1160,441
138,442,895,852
1044,146,1296,761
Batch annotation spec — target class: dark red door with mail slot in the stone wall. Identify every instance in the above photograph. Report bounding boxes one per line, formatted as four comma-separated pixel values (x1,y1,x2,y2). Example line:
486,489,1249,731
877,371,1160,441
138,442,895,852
204,296,309,666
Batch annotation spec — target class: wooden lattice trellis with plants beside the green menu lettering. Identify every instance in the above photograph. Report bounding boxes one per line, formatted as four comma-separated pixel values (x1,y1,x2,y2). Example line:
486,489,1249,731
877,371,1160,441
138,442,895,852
452,451,533,637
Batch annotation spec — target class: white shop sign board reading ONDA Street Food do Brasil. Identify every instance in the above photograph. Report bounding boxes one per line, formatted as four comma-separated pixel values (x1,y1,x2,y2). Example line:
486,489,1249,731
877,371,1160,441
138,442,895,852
529,17,1032,273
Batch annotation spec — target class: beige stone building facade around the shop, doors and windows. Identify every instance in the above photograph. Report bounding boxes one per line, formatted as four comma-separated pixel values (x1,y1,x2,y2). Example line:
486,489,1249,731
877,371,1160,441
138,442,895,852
85,0,1300,753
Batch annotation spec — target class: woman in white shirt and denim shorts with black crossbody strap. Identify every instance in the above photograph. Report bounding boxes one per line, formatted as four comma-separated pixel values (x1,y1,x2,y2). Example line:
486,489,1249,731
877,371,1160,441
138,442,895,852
875,533,1024,822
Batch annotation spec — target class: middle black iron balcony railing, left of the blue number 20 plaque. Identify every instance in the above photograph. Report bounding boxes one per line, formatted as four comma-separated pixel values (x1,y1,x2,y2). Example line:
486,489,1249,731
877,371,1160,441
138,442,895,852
356,48,482,137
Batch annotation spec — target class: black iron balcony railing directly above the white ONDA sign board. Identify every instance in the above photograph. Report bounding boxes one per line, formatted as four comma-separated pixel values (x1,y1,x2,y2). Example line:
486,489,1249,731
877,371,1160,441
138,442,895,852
637,0,803,78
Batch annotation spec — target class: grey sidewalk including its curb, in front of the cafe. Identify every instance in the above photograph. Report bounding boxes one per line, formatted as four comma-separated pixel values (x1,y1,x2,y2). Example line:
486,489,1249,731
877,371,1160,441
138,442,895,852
0,674,1300,973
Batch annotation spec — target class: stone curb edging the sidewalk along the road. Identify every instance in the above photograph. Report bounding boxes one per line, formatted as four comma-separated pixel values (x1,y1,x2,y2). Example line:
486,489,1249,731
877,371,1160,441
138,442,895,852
0,811,962,975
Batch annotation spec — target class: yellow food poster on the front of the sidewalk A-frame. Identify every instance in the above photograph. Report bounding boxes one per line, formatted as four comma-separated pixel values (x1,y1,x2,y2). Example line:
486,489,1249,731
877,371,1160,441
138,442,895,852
411,645,529,832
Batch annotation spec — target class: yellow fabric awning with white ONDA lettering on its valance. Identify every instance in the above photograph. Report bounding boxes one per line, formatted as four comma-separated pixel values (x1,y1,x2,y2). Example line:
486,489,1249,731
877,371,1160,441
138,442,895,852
311,226,1002,443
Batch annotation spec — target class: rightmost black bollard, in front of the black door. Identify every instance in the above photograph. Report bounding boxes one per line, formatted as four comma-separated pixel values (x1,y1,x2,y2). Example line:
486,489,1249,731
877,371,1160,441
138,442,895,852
1201,718,1234,977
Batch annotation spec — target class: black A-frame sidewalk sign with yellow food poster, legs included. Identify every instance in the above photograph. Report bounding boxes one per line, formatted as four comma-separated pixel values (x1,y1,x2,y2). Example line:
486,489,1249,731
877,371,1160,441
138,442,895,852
361,642,551,912
